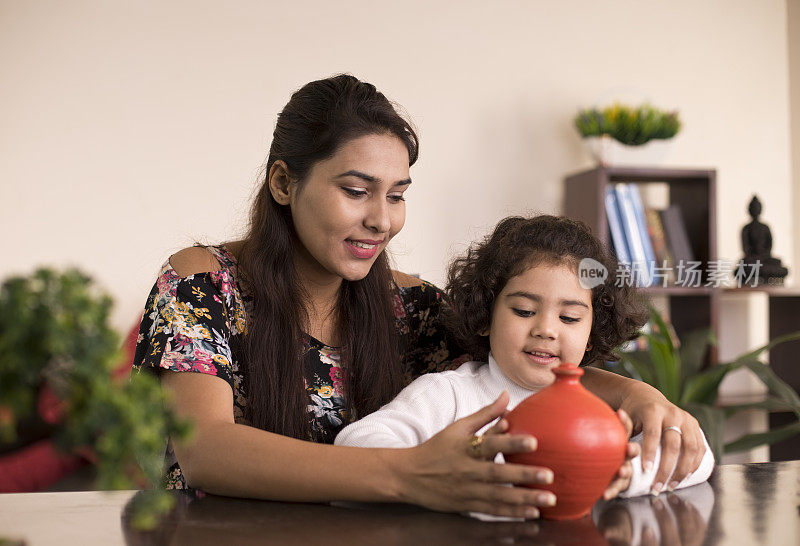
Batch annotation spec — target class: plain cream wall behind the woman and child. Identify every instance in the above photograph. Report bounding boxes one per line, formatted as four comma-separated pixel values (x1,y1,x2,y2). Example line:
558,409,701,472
0,0,796,334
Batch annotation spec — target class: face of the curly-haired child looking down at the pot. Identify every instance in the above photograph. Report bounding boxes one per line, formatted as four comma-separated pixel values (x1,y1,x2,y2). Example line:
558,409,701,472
489,264,592,389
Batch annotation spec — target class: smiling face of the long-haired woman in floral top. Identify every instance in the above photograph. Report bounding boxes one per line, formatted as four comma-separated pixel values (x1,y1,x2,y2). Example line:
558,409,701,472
289,134,411,283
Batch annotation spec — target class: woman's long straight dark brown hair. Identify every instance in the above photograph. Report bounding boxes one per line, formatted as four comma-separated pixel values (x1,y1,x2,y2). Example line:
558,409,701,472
239,75,419,439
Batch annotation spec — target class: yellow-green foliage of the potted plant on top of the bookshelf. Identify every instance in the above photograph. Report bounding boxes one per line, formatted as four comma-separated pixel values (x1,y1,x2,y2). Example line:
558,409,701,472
575,104,681,146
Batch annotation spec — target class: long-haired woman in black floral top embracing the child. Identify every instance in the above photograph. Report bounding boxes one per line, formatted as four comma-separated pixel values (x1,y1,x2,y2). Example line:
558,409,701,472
135,75,703,517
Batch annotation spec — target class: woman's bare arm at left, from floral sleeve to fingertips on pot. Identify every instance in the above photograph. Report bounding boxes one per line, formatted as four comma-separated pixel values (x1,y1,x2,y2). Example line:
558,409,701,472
162,371,548,517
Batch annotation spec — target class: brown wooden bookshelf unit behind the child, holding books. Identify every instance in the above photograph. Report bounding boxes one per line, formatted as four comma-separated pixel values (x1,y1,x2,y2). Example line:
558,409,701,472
563,167,800,461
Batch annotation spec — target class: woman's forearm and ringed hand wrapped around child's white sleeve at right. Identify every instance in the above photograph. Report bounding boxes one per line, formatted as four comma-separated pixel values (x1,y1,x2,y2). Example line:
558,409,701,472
582,367,713,492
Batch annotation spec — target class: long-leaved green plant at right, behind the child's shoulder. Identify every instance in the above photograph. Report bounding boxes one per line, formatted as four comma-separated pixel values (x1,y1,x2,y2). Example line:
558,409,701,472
604,307,800,460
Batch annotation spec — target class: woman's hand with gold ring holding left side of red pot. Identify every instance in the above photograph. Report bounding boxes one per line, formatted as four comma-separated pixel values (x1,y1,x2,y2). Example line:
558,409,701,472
398,391,556,518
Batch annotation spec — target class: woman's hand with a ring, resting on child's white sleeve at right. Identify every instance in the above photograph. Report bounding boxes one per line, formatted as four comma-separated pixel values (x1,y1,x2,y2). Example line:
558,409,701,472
620,383,705,494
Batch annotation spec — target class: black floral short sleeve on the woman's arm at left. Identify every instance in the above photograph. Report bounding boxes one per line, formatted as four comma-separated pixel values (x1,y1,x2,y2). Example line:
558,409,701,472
134,263,246,390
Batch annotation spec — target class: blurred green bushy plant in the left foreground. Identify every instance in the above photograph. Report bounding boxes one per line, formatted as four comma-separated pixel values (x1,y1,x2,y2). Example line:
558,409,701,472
0,269,190,527
